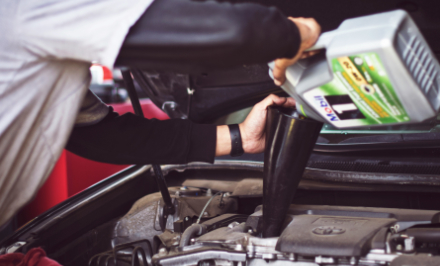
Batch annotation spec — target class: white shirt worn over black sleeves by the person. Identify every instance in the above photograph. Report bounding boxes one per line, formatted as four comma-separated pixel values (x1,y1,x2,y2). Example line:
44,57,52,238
0,0,152,225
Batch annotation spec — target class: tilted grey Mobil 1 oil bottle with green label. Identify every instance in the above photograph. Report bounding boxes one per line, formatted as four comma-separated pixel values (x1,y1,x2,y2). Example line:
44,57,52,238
270,10,440,128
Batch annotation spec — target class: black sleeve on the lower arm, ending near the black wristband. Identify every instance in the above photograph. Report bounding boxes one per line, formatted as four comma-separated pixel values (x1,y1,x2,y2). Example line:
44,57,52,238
66,108,217,164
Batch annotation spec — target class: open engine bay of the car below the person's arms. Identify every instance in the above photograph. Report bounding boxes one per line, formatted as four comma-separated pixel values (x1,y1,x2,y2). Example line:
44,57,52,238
5,160,440,266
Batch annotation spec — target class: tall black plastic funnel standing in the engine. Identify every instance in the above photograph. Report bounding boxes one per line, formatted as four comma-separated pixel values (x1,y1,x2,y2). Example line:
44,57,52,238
263,107,322,237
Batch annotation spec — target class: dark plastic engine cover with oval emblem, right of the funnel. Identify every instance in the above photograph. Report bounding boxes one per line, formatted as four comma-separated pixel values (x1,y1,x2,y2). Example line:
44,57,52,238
276,215,396,257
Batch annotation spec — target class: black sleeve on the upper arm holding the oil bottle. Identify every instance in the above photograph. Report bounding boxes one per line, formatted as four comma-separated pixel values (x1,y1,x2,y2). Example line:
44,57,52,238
116,0,300,71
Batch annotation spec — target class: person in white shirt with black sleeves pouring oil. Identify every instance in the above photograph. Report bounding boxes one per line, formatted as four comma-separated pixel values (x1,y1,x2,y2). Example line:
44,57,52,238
0,0,320,228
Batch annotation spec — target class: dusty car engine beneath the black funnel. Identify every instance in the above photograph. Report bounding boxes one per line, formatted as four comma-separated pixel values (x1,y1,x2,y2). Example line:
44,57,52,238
89,184,440,266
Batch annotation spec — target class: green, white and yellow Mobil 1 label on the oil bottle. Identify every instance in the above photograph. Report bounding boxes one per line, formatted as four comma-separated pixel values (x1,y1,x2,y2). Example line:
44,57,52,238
304,53,410,127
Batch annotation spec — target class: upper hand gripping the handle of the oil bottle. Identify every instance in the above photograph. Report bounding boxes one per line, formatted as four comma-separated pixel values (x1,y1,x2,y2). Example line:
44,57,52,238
272,17,321,86
